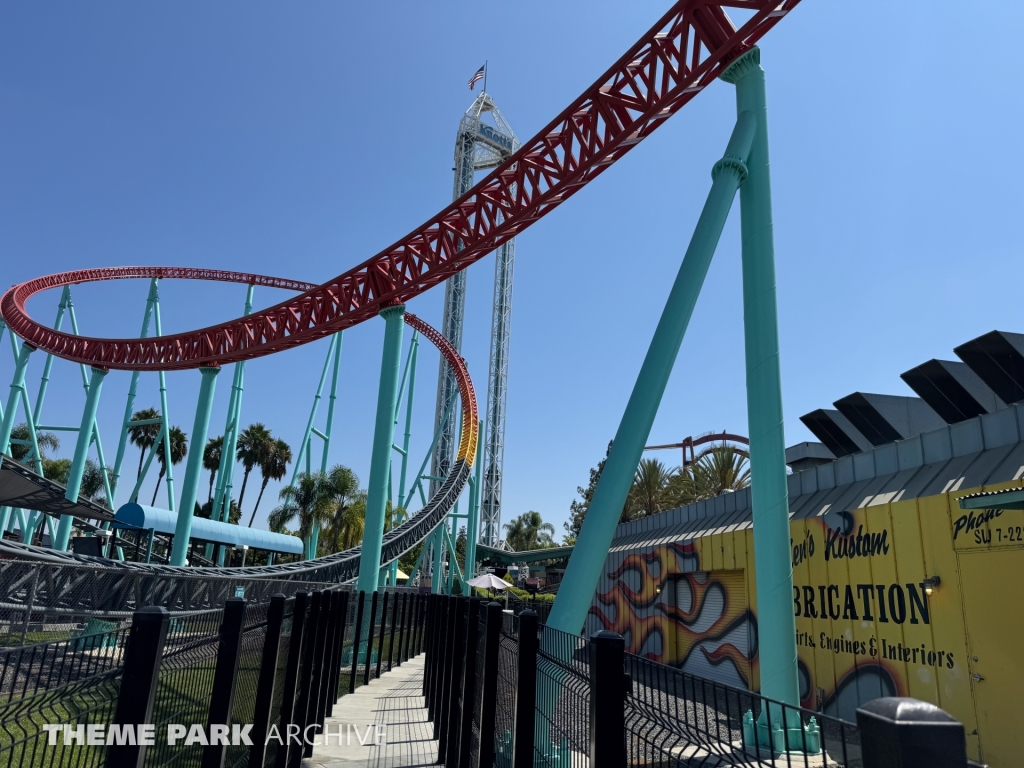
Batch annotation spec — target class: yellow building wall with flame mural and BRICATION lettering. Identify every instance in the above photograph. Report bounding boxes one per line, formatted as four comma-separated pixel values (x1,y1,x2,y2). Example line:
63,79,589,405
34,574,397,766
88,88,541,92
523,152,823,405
587,403,1024,768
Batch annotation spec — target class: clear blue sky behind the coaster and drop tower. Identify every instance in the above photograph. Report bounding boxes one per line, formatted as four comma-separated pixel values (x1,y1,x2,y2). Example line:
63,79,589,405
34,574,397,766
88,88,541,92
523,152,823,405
0,0,1024,534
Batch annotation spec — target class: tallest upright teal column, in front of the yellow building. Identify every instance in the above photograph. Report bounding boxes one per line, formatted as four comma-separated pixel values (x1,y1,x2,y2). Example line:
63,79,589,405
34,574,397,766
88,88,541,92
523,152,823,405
722,48,800,708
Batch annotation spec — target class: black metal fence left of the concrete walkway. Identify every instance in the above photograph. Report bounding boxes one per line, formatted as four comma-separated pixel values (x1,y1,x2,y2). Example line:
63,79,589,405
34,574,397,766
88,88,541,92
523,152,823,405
0,588,427,768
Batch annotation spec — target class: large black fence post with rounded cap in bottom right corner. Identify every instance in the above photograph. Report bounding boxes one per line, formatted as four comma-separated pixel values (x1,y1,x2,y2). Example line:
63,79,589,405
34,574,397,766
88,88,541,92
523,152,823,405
857,696,967,768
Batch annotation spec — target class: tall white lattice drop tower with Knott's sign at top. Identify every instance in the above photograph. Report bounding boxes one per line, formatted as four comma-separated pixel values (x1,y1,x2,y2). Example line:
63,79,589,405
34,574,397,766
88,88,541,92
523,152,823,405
431,90,519,547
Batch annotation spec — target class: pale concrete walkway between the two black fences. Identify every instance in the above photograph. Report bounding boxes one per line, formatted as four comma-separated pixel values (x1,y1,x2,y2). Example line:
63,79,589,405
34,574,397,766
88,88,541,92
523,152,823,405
302,655,437,768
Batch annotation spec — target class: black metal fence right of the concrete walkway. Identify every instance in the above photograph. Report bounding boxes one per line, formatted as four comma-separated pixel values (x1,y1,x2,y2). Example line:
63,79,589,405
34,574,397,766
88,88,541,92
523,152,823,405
424,596,862,768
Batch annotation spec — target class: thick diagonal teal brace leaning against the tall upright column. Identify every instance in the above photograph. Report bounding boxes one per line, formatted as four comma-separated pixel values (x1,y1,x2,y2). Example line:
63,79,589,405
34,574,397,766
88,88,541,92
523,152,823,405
547,113,756,635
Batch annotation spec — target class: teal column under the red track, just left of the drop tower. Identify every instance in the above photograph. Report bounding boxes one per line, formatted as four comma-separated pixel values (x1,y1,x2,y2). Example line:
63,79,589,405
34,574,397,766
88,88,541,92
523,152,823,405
356,304,406,593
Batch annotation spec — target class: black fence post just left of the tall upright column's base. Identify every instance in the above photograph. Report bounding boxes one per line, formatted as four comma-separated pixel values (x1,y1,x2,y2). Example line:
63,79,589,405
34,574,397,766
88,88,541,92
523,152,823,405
590,630,626,768
